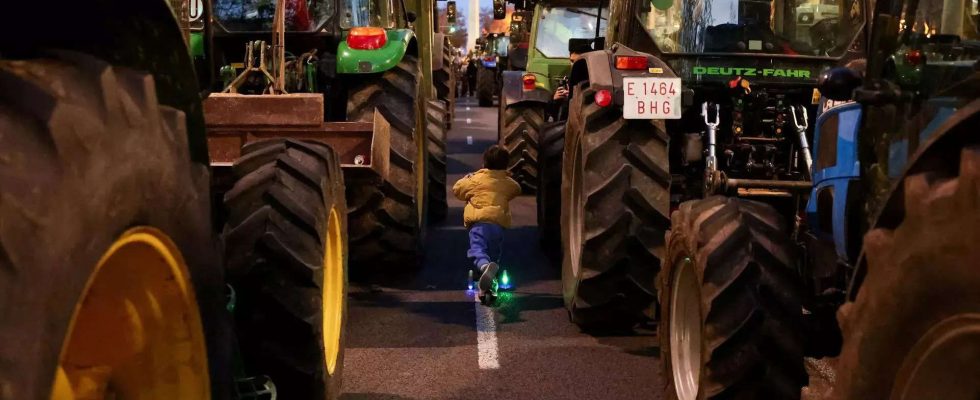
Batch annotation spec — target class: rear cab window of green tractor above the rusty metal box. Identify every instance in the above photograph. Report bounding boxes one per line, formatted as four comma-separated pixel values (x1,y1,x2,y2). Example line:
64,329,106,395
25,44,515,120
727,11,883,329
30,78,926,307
213,0,335,32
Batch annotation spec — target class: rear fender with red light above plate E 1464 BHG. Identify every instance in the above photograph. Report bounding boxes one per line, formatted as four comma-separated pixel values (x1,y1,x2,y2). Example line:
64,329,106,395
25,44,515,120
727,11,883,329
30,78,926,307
568,43,677,106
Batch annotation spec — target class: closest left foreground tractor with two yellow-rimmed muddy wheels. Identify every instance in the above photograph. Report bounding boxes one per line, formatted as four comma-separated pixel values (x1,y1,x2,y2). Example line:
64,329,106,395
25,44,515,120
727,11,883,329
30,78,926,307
0,0,356,399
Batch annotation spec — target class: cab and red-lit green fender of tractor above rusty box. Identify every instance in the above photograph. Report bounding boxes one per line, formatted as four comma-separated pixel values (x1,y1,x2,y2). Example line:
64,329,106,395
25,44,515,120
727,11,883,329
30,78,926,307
209,0,417,108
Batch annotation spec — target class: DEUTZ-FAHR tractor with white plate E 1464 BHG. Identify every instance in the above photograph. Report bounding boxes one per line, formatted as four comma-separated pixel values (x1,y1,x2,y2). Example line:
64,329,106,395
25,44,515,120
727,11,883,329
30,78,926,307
544,0,866,338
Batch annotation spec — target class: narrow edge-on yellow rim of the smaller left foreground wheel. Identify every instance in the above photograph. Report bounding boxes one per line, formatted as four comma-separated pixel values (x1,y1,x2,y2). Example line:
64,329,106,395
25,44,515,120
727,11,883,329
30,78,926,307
321,208,347,375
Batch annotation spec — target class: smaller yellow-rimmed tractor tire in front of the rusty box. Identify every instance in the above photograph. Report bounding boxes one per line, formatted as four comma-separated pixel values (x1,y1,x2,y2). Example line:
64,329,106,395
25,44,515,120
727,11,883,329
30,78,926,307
223,139,347,399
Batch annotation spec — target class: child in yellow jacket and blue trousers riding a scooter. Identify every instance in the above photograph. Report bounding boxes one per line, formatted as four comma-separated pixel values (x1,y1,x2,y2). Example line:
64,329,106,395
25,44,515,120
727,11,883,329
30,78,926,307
453,145,521,292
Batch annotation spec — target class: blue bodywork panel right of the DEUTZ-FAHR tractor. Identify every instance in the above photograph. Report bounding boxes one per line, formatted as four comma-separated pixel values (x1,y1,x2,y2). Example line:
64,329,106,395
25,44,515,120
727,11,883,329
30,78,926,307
806,103,861,260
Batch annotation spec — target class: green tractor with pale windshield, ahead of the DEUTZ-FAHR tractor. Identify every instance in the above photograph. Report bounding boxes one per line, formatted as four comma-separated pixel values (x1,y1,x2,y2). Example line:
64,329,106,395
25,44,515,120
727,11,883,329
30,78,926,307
497,1,608,195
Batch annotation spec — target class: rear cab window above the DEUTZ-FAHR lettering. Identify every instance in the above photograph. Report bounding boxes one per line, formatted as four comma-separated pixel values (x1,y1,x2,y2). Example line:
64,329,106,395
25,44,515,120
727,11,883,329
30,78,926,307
638,0,865,57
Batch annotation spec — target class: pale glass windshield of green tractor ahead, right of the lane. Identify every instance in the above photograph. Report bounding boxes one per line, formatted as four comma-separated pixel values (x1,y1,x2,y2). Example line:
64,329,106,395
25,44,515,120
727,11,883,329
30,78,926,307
534,7,609,58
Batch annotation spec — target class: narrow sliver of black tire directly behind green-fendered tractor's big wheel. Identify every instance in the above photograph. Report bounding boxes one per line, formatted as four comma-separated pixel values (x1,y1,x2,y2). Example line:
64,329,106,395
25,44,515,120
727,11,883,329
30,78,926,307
425,100,449,222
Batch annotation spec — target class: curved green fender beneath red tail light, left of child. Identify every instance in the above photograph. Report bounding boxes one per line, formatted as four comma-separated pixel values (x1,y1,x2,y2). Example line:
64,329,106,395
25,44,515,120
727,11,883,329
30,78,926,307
337,29,415,74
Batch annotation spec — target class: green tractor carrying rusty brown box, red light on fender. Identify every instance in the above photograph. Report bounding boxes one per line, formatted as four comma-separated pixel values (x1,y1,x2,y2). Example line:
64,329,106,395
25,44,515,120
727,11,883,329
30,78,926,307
205,0,456,272
